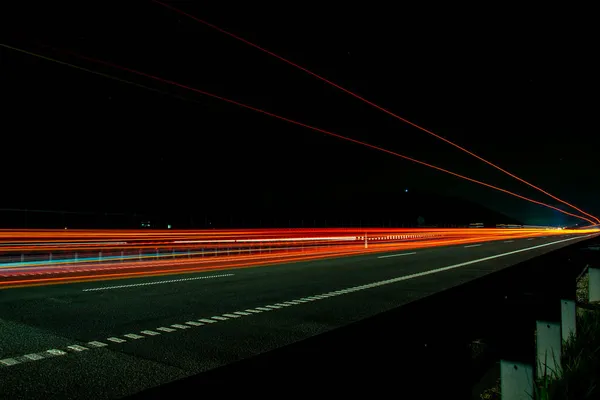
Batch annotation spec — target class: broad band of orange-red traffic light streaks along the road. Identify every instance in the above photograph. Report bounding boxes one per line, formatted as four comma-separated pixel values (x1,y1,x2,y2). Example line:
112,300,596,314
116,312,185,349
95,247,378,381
0,228,600,288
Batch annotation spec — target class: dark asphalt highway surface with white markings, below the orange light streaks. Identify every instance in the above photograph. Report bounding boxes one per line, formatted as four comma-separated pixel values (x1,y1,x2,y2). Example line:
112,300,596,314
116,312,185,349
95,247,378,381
0,234,598,399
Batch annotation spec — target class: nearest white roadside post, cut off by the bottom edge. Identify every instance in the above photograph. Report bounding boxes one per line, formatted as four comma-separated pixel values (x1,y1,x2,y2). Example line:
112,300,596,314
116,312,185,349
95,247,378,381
500,360,533,400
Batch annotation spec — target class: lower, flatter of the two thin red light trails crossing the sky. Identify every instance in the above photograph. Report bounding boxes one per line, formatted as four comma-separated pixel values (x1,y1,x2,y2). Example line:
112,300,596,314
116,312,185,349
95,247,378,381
0,43,595,225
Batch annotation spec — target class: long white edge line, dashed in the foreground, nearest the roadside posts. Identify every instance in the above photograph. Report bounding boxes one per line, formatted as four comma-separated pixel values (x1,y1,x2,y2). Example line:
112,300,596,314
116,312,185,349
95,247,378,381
0,235,590,367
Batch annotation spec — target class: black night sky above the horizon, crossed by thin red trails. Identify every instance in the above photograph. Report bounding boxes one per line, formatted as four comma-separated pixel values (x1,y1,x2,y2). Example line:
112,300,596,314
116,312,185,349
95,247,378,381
0,1,600,223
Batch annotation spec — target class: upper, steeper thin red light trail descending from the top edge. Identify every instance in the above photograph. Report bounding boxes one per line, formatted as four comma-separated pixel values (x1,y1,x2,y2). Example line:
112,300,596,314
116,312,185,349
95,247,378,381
152,0,600,224
